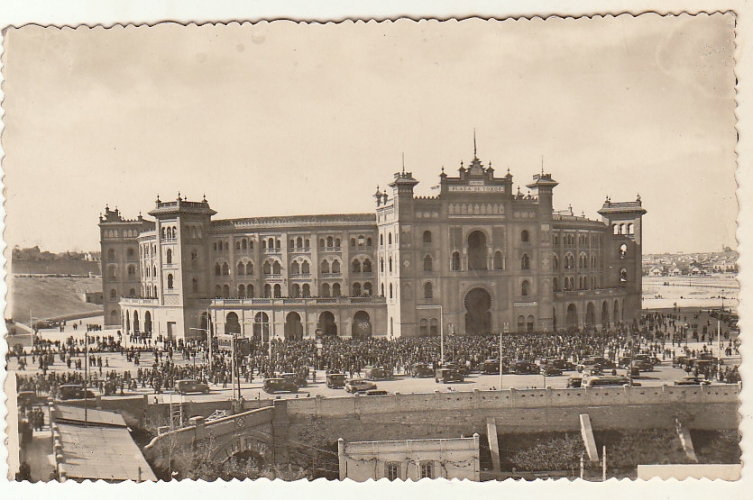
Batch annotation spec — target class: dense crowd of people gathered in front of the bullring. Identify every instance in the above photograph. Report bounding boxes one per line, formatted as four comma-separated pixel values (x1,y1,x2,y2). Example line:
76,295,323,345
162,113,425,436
9,310,739,397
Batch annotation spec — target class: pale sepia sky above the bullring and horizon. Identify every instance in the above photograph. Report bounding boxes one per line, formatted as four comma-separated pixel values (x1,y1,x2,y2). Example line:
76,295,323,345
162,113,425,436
1,14,737,253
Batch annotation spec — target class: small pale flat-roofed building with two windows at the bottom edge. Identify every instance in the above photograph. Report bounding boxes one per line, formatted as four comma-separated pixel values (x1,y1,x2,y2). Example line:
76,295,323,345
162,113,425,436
337,434,481,482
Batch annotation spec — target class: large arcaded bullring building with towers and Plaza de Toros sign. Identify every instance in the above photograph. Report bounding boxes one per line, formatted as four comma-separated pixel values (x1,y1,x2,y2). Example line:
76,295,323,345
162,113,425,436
99,149,646,340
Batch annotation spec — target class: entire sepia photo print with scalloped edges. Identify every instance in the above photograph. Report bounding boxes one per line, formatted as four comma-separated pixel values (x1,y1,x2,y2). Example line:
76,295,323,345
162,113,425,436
2,7,742,492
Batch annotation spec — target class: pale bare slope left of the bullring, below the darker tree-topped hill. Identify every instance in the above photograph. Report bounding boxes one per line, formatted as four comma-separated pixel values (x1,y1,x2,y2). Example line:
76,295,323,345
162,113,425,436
5,275,102,323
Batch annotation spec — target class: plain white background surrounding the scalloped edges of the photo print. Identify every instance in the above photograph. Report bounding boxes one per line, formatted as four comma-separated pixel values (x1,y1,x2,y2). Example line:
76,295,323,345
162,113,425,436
0,0,753,500
